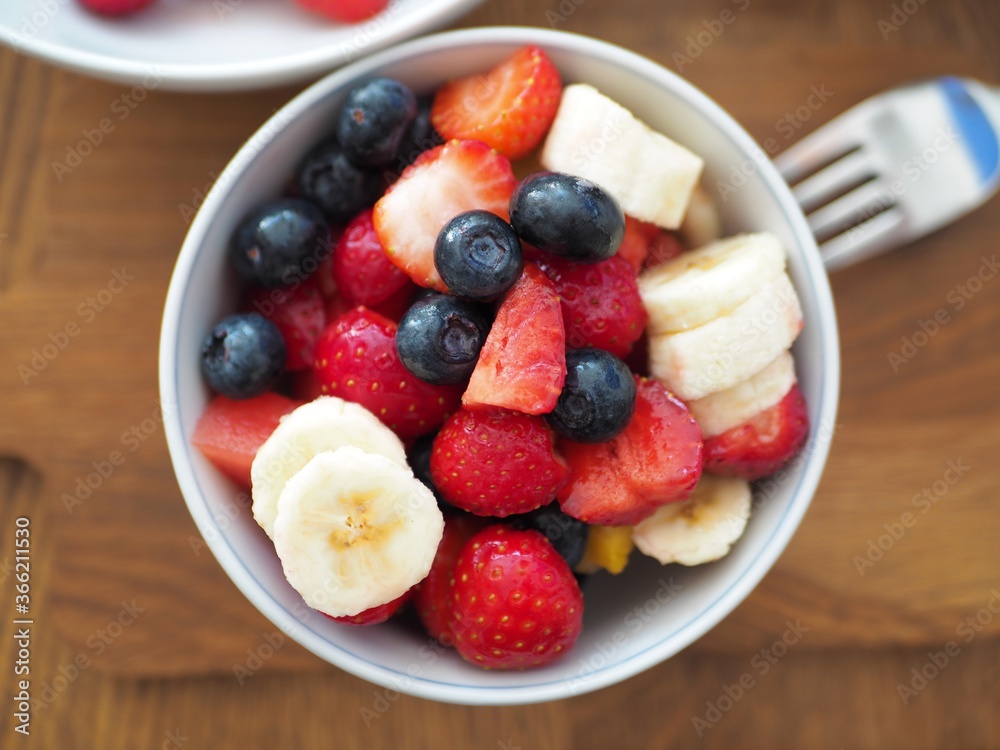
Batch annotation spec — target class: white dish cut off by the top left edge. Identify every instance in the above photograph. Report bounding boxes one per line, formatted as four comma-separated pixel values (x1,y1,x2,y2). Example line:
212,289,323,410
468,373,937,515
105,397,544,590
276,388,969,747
0,0,482,91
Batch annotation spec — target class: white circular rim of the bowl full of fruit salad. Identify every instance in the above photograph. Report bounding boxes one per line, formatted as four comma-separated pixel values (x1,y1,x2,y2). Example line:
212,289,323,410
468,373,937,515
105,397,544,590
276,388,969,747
159,26,840,705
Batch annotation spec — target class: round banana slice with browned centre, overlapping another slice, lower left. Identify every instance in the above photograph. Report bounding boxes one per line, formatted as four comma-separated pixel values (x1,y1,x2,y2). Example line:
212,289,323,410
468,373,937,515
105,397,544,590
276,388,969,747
274,446,444,617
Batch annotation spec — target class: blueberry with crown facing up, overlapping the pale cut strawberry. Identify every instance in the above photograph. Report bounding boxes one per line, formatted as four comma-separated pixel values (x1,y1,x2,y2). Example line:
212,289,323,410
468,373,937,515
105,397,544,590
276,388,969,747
434,211,524,301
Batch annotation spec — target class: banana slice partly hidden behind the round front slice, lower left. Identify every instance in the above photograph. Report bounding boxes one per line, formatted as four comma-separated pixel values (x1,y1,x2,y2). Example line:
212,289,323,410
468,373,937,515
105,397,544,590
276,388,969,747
250,396,407,539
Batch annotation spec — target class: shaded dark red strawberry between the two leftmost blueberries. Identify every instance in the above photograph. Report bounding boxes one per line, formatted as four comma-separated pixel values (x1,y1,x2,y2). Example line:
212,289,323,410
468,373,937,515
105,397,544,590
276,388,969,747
247,278,326,371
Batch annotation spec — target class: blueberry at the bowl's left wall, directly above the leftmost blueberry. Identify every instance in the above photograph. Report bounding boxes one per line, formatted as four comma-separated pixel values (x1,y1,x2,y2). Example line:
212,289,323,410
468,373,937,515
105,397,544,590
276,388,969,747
229,198,330,288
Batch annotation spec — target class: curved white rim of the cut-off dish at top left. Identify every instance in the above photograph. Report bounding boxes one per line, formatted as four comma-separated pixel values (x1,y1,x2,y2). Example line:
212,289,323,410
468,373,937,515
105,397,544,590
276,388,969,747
0,0,483,92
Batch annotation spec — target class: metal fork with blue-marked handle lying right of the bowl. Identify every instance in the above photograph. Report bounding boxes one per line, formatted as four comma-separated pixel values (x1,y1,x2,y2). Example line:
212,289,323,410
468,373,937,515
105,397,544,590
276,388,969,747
775,77,1000,270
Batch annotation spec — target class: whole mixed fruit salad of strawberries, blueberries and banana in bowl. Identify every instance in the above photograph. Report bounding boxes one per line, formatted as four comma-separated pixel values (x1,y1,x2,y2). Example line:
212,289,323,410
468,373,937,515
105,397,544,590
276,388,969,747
192,46,809,669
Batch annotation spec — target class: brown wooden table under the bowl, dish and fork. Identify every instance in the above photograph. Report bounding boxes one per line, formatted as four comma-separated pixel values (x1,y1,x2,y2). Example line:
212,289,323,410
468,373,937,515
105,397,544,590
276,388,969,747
0,0,1000,750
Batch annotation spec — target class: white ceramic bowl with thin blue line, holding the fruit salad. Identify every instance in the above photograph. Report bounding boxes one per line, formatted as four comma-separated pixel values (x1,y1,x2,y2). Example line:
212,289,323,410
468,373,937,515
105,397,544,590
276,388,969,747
160,28,839,704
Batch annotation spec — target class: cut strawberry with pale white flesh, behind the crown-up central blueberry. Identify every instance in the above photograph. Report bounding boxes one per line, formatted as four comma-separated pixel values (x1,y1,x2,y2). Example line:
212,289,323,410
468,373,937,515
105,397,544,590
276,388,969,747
374,141,517,292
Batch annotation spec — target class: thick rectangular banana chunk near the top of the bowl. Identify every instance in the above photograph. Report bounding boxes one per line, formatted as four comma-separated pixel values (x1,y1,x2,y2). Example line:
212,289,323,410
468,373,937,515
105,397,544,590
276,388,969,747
539,83,704,229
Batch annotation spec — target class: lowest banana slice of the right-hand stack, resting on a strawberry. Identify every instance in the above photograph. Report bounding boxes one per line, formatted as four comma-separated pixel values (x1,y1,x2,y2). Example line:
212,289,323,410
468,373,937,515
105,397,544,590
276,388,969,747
687,352,795,438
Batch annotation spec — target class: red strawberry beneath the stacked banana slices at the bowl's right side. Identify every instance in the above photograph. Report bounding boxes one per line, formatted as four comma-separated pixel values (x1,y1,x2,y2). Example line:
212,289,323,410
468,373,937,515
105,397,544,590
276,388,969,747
705,385,809,480
